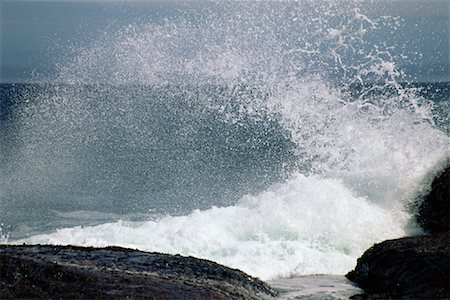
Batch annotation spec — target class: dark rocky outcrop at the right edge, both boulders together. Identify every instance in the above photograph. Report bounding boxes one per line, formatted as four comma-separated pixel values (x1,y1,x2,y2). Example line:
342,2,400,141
346,160,450,299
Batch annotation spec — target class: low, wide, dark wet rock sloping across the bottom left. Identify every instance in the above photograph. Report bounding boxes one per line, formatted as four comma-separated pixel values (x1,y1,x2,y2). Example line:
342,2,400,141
0,245,276,299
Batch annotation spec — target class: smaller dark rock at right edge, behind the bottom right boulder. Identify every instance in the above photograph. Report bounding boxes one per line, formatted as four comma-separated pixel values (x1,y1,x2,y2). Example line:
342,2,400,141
416,161,450,233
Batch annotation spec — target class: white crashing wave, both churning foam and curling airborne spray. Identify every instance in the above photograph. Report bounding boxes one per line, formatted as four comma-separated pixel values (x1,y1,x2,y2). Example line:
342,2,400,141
7,1,449,279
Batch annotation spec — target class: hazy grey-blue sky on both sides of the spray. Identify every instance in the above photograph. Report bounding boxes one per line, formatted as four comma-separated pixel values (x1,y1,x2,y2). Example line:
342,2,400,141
0,0,450,82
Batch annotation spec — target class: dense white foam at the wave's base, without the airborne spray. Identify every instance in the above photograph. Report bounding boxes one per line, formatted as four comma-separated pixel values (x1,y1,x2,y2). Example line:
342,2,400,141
17,174,406,279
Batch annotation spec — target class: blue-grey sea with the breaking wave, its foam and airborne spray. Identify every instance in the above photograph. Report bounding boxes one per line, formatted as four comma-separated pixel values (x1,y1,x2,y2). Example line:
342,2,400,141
0,1,450,279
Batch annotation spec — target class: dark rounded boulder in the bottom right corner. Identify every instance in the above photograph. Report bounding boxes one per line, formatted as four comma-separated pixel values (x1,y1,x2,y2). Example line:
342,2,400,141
346,233,450,299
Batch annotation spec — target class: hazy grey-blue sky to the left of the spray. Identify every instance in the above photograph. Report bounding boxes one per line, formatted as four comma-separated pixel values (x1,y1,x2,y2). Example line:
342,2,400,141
0,0,179,82
